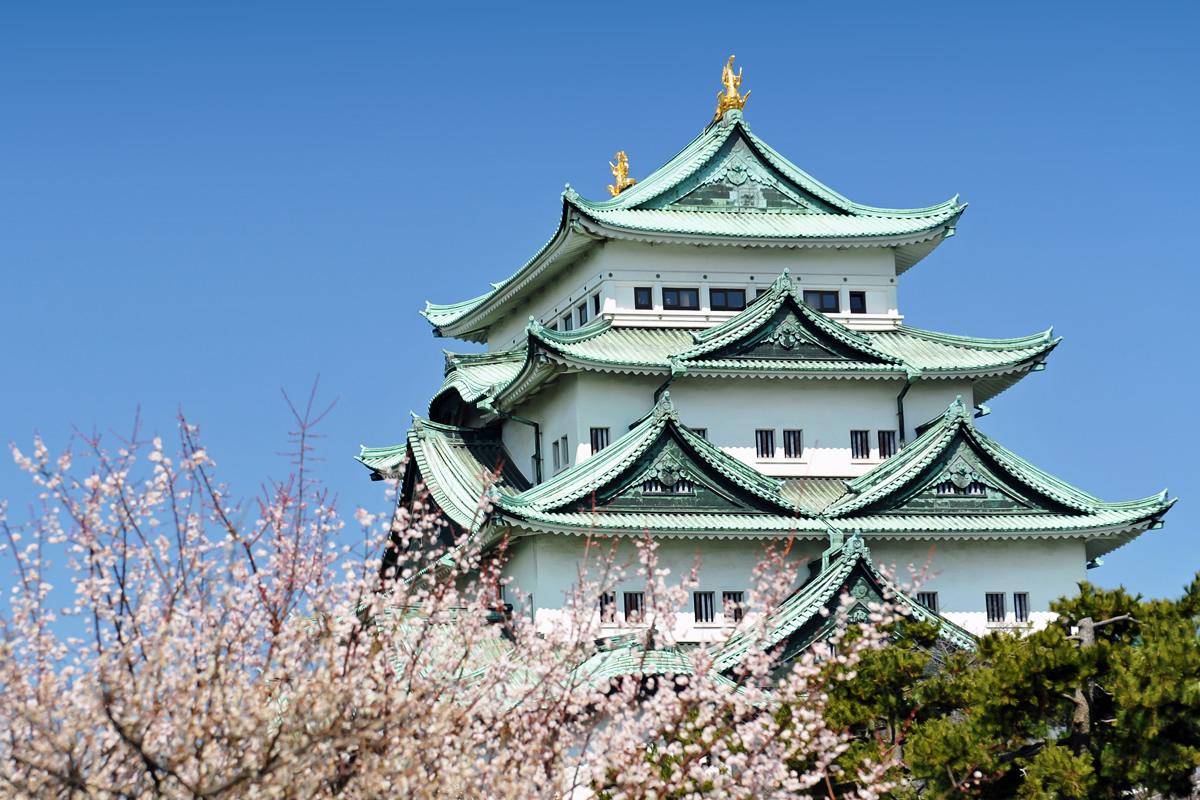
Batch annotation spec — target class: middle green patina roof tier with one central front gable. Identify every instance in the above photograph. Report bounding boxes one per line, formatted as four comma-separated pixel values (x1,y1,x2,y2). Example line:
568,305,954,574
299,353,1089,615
431,272,1062,417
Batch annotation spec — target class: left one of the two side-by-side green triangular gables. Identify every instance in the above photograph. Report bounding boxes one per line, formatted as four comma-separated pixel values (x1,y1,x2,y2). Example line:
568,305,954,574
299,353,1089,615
497,392,809,517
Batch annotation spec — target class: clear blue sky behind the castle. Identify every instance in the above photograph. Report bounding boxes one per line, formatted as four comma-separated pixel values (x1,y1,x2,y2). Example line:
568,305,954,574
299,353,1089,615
0,0,1200,595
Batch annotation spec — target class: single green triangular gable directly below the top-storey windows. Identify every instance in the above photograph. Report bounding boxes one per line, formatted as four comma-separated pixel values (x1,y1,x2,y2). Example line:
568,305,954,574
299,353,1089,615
676,270,902,368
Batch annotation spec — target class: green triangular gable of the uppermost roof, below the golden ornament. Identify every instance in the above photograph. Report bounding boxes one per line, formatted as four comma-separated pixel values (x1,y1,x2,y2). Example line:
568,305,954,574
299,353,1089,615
635,134,844,213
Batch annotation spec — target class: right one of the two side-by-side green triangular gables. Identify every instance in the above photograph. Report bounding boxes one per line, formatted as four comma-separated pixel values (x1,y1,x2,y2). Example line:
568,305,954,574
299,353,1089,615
826,397,1099,517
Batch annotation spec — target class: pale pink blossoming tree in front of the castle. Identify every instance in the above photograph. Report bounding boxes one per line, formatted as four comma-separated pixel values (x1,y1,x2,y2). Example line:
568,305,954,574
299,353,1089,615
0,401,899,800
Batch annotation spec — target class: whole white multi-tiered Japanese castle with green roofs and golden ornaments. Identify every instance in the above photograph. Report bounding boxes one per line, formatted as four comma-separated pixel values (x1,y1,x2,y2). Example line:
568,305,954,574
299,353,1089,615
360,58,1174,642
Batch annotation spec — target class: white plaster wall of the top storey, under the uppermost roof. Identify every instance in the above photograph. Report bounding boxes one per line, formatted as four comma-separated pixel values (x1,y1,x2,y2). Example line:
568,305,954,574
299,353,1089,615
488,240,900,351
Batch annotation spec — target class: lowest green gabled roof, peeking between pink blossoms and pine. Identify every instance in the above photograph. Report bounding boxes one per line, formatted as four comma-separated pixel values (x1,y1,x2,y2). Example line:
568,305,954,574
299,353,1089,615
713,533,976,672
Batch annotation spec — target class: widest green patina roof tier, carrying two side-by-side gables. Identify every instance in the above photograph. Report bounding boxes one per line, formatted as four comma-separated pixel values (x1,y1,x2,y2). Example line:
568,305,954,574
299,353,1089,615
374,393,1175,558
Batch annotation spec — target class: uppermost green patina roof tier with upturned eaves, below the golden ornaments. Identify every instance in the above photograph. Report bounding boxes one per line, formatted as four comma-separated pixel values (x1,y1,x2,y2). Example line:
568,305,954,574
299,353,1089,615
422,110,966,341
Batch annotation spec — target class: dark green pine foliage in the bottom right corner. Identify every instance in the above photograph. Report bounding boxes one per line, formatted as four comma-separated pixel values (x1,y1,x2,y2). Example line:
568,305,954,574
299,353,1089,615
828,575,1200,800
